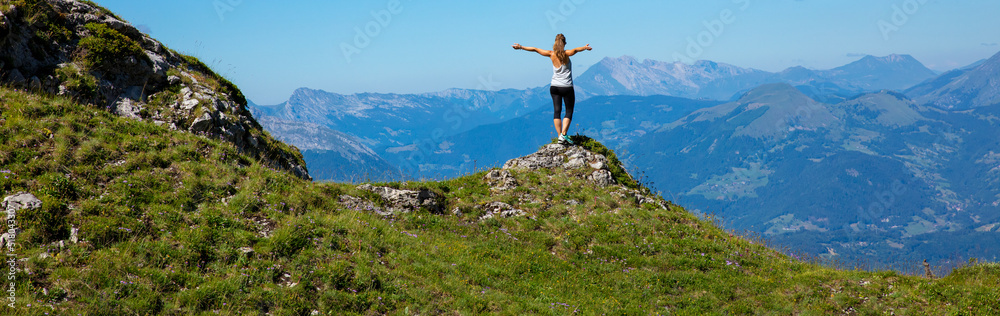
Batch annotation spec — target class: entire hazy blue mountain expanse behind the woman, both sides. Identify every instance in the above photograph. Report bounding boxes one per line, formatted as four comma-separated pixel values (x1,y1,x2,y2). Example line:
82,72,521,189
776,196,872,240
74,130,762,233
254,51,1000,264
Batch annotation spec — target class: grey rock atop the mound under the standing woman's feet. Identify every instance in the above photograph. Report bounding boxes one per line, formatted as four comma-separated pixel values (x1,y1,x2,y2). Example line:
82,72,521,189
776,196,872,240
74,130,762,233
503,144,617,187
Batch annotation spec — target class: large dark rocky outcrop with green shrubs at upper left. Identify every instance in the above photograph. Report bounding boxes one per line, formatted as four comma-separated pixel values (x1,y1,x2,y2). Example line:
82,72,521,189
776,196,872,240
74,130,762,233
0,0,311,179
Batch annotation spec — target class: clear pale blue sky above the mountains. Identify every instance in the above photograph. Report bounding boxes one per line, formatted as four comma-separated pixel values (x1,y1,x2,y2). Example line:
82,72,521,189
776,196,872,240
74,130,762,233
95,0,1000,104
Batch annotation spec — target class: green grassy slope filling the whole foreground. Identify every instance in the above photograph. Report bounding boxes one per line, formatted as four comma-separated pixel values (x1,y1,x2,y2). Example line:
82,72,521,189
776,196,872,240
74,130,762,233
0,88,1000,315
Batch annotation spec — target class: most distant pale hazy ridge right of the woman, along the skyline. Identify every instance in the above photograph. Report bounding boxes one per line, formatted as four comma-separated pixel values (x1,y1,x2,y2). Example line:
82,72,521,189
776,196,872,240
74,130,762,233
575,55,935,100
